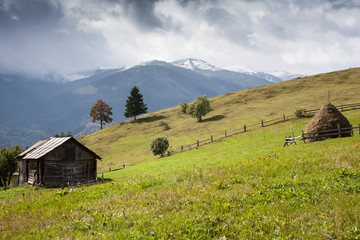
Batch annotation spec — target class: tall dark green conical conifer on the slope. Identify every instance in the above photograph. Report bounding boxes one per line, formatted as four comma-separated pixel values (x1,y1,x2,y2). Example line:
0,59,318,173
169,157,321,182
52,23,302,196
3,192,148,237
124,86,148,121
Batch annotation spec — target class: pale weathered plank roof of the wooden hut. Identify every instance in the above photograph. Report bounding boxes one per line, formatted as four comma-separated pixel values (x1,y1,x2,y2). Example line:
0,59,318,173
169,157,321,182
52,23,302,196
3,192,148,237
17,137,101,159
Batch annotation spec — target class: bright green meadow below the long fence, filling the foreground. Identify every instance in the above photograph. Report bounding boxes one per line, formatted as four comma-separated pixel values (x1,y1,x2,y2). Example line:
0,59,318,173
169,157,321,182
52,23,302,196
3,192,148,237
0,110,360,239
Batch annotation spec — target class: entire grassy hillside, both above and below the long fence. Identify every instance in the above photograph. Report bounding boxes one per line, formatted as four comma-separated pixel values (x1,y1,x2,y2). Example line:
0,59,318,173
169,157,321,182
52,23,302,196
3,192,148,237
0,69,360,239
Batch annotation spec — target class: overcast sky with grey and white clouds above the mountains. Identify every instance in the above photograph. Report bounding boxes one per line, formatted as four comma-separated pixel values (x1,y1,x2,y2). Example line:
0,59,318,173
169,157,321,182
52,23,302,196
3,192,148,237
0,0,360,74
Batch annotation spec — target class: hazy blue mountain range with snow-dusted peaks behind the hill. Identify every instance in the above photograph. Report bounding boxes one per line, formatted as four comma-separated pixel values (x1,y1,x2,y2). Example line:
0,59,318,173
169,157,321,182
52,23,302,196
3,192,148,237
0,59,303,147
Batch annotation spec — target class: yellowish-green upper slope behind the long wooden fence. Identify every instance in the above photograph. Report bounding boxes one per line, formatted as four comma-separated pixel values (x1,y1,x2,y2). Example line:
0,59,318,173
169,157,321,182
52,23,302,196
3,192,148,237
80,69,360,172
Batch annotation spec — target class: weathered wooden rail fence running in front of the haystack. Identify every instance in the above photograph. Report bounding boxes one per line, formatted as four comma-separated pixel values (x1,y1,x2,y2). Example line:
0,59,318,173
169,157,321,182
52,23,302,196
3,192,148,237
284,124,360,147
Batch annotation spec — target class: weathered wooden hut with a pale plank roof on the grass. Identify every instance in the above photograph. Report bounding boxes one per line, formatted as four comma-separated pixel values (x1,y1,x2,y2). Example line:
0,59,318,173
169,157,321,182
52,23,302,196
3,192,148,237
17,137,101,186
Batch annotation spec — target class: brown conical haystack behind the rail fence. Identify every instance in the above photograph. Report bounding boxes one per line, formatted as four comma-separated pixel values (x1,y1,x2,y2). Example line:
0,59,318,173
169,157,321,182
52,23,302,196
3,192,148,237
305,103,351,142
